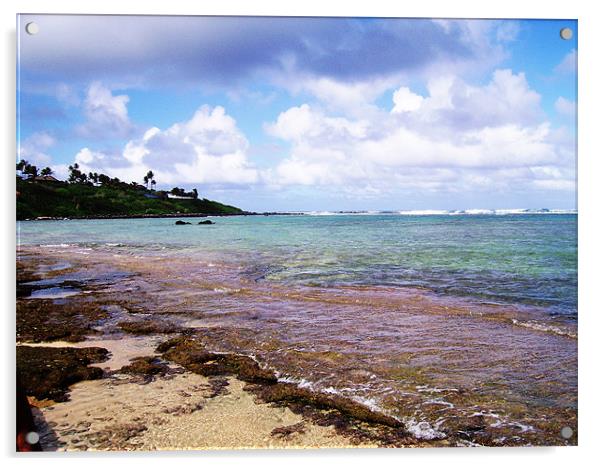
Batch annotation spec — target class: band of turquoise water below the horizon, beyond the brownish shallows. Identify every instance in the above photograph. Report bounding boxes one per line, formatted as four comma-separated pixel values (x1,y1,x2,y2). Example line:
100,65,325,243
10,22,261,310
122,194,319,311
18,214,577,317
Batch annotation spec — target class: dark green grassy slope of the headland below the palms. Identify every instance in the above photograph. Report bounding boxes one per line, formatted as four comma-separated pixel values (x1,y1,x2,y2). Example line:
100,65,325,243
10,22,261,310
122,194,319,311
17,180,242,220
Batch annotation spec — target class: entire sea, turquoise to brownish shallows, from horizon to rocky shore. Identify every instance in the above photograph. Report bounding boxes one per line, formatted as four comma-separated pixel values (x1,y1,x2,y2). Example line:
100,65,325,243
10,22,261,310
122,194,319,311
19,215,577,444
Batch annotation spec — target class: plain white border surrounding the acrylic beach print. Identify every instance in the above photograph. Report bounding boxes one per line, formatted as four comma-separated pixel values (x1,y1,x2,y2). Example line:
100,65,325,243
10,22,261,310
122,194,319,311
0,0,602,466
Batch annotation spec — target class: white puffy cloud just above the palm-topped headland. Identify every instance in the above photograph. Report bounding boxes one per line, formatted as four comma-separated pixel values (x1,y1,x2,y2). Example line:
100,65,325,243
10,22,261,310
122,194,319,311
70,106,259,185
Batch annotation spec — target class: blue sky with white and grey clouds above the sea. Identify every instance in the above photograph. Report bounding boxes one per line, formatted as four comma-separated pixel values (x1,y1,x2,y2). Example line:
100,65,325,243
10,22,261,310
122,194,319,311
17,15,577,211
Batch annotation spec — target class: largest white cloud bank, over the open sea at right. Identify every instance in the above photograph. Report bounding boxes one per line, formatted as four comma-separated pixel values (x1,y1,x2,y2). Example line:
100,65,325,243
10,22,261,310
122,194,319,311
265,70,574,193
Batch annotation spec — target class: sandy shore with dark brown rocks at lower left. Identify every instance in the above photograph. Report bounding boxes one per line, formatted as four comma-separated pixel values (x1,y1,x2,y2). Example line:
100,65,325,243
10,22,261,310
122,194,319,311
17,251,436,450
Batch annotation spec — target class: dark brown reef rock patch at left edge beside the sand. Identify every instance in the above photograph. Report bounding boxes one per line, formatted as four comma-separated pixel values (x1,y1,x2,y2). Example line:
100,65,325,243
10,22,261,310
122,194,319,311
17,346,109,401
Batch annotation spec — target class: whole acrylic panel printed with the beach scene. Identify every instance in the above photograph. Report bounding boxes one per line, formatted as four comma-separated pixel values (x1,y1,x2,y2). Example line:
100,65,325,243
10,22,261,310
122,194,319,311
16,14,578,451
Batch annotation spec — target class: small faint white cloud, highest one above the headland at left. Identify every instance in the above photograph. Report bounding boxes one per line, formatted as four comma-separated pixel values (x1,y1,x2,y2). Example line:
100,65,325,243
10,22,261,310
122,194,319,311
78,81,133,139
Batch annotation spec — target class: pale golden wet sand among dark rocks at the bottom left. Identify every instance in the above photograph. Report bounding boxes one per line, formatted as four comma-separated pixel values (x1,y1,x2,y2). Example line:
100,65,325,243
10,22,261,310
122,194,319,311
30,337,375,451
